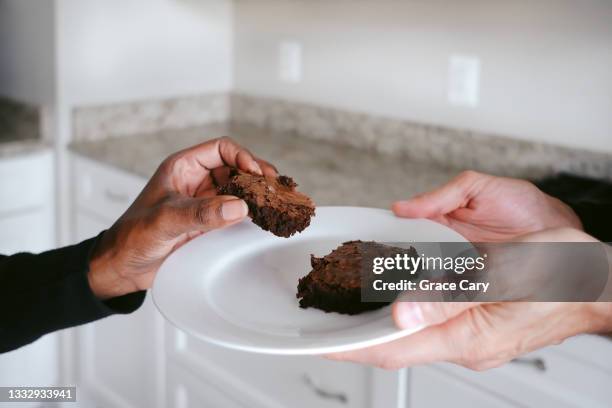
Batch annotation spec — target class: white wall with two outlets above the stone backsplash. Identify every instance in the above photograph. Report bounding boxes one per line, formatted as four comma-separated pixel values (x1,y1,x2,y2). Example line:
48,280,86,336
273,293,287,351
234,0,612,151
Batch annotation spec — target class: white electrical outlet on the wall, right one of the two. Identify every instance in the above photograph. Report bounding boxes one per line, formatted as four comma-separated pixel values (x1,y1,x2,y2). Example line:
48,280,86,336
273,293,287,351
448,55,480,108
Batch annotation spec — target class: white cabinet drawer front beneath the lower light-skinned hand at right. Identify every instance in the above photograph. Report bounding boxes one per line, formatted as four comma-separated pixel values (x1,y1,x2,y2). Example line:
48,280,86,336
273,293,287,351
438,345,612,407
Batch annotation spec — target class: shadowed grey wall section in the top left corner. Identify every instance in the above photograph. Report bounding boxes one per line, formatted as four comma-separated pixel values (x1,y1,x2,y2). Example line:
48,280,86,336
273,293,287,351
0,0,55,105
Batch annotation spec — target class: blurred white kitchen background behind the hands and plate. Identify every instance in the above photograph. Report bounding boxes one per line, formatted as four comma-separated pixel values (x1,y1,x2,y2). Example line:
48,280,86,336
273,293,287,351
0,0,612,408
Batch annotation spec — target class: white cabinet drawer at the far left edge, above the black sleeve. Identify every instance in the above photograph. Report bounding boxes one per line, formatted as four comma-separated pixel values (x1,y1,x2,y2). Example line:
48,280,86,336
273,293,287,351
0,151,53,216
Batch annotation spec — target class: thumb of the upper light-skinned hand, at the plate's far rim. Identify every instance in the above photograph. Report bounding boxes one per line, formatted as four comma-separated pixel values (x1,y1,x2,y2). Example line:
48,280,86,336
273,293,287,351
391,171,485,218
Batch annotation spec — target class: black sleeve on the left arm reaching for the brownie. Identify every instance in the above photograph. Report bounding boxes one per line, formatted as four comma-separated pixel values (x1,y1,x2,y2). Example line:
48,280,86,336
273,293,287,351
0,236,146,353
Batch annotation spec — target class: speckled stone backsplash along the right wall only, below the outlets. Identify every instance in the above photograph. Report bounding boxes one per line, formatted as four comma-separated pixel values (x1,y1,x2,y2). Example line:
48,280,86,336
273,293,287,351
230,94,612,179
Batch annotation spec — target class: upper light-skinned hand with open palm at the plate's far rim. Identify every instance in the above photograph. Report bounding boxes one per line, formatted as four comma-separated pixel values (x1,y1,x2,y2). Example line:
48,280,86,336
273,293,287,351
392,171,582,242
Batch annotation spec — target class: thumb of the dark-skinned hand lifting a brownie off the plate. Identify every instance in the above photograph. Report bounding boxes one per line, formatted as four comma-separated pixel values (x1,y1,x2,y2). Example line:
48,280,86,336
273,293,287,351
159,196,249,236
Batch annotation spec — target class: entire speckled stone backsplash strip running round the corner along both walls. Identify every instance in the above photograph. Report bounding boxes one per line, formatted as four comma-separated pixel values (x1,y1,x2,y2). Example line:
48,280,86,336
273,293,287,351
73,93,612,179
